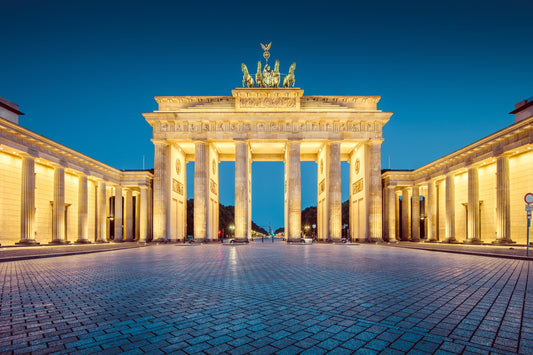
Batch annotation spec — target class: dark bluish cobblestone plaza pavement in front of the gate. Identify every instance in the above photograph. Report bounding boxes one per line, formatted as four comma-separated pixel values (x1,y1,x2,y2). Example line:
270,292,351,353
0,242,533,354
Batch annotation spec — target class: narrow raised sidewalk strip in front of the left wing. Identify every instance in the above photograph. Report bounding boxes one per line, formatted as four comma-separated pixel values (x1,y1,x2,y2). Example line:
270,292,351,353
0,242,146,262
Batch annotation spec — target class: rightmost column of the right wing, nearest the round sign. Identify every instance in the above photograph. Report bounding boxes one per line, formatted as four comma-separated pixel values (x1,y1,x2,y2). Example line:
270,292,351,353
495,155,514,244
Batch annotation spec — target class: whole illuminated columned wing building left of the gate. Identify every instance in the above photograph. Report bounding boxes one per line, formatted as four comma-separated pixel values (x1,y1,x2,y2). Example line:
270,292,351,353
0,99,152,245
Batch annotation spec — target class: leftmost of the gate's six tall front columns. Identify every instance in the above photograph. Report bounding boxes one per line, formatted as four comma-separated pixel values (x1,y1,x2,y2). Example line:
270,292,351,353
153,142,170,242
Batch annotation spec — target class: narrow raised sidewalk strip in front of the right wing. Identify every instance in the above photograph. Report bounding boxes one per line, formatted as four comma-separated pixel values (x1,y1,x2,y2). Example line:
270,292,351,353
387,242,533,260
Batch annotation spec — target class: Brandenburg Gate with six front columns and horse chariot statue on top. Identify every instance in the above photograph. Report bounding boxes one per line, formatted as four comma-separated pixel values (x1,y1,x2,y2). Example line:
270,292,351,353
143,47,392,242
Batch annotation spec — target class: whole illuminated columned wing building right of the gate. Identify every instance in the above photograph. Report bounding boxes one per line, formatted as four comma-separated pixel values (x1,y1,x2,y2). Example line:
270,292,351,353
382,99,533,244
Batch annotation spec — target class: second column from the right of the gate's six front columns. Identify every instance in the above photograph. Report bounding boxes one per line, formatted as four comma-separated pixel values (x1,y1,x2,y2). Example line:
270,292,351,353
328,143,340,242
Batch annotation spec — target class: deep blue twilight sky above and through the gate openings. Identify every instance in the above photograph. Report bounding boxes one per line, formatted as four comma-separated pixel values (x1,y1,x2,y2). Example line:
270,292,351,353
0,0,533,228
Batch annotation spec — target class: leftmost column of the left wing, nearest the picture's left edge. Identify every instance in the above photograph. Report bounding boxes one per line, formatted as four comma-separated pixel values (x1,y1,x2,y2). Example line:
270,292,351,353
16,156,39,245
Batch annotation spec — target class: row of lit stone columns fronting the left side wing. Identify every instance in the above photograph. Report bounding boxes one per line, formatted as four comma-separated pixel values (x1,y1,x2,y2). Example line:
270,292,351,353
17,154,151,245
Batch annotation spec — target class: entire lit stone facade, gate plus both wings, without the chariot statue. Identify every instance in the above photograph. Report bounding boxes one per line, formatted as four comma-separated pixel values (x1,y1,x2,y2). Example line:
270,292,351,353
0,88,533,245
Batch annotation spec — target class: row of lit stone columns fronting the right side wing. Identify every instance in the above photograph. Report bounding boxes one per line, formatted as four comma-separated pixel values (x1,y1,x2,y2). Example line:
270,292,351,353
384,154,513,244
